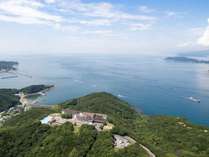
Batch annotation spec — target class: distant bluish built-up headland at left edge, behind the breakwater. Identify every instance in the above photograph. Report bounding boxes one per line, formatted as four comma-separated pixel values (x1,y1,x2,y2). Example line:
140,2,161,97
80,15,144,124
0,61,19,72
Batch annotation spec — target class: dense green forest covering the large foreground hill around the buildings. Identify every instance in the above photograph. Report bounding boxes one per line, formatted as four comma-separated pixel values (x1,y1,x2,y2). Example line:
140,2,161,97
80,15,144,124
0,93,209,157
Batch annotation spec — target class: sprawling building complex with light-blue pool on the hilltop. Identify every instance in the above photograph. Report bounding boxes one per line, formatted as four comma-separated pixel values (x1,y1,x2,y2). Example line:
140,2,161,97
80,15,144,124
41,109,109,131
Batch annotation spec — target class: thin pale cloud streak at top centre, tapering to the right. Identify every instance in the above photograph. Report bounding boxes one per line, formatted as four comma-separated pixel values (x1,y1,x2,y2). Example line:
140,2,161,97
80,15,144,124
58,0,155,21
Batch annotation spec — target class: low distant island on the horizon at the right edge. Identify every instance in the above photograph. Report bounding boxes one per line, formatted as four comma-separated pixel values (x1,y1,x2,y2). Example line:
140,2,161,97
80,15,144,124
165,56,209,64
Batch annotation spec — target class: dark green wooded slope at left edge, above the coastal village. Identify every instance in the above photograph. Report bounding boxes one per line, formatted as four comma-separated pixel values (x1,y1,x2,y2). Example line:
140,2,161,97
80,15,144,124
0,89,19,112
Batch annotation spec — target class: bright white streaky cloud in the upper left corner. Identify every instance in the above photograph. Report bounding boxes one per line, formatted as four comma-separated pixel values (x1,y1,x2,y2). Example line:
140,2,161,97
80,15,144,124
0,0,63,24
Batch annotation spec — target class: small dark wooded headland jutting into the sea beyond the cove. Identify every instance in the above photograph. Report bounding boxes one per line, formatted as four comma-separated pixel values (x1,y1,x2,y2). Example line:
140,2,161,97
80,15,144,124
20,85,53,94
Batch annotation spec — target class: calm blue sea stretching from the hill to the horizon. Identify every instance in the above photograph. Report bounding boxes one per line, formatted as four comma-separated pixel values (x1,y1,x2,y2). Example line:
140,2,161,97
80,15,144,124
0,56,209,126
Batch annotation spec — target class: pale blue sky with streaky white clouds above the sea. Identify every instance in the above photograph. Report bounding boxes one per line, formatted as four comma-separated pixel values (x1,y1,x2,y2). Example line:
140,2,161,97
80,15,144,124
0,0,209,55
